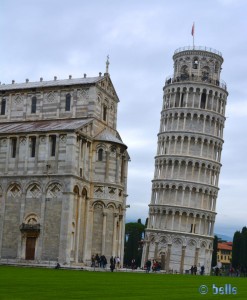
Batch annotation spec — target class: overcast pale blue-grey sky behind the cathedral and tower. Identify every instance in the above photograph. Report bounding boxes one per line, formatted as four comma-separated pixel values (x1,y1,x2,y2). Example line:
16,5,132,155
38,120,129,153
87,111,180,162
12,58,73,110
0,0,247,236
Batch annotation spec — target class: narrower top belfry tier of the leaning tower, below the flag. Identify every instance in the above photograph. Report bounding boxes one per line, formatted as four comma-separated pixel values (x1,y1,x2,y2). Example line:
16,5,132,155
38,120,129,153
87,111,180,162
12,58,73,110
173,46,224,82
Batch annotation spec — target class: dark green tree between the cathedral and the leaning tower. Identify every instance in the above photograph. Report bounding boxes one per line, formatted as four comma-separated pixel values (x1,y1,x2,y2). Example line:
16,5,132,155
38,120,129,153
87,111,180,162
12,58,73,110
124,219,145,266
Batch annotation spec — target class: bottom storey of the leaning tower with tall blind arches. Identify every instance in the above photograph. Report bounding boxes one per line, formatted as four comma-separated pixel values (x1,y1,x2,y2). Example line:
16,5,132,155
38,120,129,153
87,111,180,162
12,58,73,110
142,230,213,274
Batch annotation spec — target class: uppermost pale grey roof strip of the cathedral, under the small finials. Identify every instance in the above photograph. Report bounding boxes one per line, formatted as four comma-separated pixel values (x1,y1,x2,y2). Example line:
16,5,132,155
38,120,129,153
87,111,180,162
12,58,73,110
0,76,104,91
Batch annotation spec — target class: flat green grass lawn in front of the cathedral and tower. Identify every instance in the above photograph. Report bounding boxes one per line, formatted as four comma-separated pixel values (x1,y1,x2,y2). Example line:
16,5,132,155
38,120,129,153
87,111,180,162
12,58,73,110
0,266,247,300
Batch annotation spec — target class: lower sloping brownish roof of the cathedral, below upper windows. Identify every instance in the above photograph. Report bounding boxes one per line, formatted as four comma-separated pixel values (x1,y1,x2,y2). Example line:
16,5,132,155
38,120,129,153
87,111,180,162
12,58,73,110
0,119,92,134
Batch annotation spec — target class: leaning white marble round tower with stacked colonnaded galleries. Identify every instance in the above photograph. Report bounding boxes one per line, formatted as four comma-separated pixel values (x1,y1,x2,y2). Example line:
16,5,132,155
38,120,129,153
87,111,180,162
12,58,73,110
142,47,228,273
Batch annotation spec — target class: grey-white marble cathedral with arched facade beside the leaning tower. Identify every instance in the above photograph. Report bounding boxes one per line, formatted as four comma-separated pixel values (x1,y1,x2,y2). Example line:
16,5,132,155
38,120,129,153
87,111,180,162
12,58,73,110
0,61,129,265
